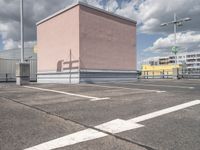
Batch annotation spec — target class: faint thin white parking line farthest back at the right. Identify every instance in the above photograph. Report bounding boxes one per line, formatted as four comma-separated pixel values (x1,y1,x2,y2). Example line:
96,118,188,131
120,82,194,89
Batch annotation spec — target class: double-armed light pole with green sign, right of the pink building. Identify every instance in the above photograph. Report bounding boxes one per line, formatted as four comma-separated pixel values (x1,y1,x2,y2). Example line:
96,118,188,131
161,13,192,64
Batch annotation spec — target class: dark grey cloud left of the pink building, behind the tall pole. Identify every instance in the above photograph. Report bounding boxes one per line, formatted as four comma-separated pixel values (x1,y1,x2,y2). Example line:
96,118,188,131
0,0,74,49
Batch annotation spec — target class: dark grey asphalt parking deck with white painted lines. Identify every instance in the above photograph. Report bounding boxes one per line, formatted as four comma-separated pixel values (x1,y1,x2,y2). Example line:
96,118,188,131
0,80,200,150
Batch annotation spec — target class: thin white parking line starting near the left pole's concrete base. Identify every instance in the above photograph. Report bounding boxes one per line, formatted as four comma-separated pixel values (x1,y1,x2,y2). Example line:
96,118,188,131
24,86,110,101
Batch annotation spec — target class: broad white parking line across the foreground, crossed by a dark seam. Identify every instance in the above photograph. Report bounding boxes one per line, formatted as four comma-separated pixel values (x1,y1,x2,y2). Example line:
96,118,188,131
25,100,200,150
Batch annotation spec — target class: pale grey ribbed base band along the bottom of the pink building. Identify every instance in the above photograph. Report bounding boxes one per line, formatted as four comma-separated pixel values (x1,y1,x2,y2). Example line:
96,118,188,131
37,70,137,84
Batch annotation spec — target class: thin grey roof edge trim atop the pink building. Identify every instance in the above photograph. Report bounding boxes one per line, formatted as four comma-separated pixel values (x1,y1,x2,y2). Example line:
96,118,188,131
36,2,137,25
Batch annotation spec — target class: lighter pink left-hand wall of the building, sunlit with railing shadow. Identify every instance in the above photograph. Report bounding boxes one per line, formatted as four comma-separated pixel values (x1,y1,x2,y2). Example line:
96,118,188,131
37,6,79,72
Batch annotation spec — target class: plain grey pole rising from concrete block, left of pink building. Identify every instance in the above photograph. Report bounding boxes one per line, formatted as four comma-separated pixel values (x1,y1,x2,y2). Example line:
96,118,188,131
20,0,24,63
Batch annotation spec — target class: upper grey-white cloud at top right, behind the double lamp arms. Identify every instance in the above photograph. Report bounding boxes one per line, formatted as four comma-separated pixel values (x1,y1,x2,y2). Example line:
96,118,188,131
138,0,200,34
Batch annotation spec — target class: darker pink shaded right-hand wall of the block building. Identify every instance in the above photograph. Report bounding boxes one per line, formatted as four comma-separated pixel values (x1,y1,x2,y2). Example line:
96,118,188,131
80,6,136,70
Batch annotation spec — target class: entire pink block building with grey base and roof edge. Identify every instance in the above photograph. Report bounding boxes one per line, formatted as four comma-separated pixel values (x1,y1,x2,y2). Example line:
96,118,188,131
37,2,136,83
